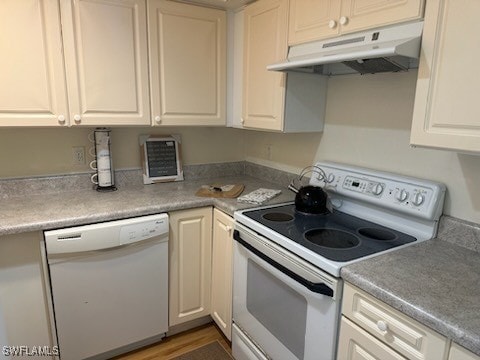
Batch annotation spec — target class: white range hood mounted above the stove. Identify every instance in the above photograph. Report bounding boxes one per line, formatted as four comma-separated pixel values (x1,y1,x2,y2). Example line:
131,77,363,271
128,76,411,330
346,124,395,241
267,21,423,75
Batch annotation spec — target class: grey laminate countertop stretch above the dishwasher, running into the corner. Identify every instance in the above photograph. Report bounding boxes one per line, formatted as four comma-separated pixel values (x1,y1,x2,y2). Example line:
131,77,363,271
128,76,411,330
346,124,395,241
0,175,294,236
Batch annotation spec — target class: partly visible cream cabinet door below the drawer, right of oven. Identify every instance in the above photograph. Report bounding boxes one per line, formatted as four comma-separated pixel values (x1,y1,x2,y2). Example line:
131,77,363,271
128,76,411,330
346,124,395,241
337,316,407,360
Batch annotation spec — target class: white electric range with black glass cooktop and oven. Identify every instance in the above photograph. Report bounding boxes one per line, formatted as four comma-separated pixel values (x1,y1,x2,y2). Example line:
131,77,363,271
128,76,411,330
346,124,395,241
232,162,445,360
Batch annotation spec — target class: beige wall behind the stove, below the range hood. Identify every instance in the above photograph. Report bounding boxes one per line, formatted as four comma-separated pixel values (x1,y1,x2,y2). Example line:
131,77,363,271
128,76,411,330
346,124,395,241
245,71,480,223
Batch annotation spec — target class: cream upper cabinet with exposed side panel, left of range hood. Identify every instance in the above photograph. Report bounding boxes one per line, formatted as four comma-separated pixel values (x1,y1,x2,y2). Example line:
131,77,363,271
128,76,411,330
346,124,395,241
241,0,327,132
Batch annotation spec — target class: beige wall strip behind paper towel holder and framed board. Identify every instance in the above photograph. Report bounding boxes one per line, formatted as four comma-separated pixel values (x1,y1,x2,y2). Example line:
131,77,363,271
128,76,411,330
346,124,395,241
0,127,244,178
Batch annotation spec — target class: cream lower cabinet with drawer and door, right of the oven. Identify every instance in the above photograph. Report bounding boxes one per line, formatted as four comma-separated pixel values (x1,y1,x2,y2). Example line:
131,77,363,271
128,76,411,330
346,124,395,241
337,283,449,360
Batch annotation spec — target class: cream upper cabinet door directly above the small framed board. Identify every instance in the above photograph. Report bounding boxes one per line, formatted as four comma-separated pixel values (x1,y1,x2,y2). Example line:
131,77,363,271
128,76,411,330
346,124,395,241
148,0,226,125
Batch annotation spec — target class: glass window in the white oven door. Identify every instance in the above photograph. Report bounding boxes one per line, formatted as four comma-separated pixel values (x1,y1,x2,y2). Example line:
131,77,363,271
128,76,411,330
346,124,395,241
246,259,308,359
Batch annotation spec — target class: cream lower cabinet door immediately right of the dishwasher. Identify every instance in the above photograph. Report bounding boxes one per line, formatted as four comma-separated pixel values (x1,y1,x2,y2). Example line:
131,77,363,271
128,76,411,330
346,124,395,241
169,207,212,326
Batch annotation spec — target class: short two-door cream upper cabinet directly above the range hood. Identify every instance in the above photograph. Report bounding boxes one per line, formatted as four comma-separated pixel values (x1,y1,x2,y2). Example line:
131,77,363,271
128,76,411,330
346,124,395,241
288,0,424,45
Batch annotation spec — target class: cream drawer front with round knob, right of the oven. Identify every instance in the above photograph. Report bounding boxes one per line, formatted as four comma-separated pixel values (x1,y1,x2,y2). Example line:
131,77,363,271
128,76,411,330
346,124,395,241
342,284,447,360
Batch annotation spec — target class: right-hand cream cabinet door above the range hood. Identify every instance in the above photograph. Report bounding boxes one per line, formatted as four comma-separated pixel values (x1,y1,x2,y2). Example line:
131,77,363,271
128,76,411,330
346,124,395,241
339,0,424,34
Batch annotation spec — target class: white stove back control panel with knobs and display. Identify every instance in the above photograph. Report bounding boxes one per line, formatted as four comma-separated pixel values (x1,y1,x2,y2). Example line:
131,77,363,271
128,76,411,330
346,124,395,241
310,163,445,219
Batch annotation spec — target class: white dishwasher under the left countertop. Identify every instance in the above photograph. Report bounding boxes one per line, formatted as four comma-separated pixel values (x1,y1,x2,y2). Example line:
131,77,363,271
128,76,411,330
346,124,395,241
44,214,168,360
